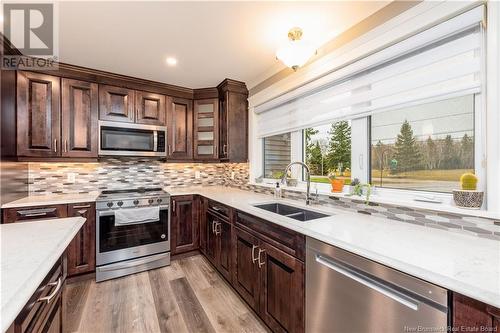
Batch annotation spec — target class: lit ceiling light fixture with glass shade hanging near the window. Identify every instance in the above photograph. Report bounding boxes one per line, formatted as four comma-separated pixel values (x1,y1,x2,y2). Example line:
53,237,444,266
276,27,316,71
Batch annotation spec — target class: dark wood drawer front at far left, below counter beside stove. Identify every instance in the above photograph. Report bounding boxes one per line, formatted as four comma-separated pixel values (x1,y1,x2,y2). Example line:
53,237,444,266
3,205,68,223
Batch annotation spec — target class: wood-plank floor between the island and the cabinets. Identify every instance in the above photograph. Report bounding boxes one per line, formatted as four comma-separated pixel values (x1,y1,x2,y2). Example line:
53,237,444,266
64,255,269,333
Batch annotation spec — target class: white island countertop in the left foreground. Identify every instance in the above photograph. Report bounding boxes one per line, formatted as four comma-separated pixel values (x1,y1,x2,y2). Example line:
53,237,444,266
0,217,85,332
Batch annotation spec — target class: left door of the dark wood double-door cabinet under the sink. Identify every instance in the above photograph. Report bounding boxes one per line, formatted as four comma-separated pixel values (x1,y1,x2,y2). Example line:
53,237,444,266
232,228,260,311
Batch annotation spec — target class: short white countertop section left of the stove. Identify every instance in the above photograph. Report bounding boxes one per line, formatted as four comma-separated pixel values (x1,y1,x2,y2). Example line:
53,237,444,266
2,192,99,208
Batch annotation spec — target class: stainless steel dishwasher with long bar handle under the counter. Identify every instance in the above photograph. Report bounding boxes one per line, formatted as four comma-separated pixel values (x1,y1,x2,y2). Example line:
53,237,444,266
306,238,448,333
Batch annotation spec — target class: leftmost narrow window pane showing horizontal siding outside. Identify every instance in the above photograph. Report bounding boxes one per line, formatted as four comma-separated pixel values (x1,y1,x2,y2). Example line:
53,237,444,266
264,133,291,178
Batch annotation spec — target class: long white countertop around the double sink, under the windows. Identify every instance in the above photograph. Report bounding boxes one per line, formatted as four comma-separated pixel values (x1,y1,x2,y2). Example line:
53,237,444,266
165,186,500,308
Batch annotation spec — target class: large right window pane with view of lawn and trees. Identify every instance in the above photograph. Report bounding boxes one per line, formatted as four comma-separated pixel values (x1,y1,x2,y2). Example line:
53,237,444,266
371,95,474,192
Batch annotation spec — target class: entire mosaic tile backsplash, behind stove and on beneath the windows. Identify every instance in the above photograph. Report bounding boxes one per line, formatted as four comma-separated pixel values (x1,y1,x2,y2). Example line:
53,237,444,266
28,158,500,241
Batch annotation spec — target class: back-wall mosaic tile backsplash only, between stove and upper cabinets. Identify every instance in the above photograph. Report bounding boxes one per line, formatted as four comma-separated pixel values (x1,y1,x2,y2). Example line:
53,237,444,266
28,158,248,195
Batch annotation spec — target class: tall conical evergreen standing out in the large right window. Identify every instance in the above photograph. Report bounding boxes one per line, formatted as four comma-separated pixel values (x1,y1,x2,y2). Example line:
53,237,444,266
394,120,422,172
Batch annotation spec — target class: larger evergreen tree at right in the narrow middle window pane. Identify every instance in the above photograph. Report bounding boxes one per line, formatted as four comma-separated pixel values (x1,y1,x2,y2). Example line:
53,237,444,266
326,121,351,170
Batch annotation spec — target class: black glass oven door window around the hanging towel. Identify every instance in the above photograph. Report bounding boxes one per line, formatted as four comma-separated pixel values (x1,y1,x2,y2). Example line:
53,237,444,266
99,209,168,252
